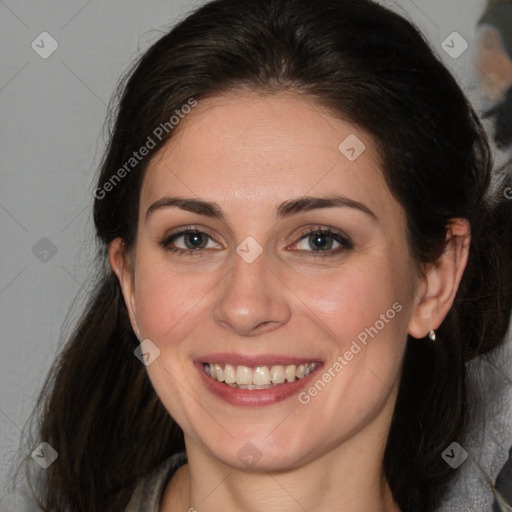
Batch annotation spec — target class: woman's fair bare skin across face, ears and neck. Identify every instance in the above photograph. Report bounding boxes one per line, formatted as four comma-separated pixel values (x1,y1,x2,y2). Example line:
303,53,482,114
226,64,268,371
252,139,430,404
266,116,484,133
110,91,469,512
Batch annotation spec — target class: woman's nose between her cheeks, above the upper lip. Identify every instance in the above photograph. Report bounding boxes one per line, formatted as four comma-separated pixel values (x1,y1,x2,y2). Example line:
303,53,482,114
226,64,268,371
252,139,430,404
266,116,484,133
213,252,291,336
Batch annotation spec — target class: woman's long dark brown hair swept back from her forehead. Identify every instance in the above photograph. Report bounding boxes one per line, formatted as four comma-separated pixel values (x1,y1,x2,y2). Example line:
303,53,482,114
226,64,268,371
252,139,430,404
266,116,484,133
17,0,512,512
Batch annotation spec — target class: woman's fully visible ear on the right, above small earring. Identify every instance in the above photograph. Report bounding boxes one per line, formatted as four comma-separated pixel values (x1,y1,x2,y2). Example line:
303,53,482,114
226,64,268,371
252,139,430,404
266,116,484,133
408,218,471,338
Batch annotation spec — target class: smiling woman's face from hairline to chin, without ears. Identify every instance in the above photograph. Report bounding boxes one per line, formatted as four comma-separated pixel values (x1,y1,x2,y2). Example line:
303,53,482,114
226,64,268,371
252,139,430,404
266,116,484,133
118,93,418,470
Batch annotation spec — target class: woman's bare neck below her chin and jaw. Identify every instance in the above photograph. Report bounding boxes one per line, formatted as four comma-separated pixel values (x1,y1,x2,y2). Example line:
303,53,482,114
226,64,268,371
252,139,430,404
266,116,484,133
160,426,400,512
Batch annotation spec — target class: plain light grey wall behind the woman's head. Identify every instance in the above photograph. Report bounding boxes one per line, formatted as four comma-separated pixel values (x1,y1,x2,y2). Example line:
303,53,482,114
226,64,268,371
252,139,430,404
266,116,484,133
0,0,500,508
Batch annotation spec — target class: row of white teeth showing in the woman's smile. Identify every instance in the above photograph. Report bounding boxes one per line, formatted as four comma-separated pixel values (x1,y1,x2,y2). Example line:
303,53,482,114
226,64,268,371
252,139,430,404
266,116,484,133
202,362,320,389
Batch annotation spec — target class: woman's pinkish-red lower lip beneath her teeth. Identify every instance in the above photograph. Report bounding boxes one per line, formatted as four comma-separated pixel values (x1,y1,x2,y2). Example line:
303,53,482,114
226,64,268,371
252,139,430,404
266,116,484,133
194,363,322,406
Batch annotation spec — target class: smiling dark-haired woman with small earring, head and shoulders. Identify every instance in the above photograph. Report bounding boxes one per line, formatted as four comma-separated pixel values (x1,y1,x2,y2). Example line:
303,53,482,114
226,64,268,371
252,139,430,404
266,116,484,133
18,0,511,512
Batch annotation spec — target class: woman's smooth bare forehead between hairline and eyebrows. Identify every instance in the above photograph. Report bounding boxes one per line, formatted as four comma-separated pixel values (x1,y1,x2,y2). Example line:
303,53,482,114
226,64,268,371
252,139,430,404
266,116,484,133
141,93,396,222
